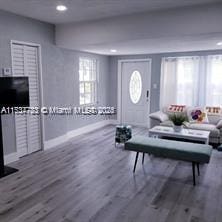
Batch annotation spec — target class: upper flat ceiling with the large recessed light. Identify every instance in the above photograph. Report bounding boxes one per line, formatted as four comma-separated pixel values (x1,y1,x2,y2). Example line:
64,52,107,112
0,0,221,24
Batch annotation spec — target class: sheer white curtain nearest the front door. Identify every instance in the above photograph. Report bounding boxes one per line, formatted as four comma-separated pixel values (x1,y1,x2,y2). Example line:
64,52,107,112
160,56,200,107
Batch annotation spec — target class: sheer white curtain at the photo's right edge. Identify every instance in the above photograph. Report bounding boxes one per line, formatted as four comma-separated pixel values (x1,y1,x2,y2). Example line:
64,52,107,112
205,55,222,106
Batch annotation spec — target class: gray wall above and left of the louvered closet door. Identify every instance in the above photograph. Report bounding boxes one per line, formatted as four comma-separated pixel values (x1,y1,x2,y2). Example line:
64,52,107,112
0,11,54,154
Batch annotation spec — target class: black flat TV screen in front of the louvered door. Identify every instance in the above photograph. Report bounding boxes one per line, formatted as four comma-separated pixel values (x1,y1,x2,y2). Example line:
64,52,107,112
0,77,29,107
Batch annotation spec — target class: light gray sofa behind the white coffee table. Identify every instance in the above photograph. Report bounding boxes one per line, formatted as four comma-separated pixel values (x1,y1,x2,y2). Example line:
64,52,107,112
149,111,222,144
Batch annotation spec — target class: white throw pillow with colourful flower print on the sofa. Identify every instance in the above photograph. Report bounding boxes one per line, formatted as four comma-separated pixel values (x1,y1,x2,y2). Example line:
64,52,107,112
187,107,209,123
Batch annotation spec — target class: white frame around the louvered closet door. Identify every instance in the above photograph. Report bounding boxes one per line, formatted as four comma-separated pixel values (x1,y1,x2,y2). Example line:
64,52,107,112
11,40,45,151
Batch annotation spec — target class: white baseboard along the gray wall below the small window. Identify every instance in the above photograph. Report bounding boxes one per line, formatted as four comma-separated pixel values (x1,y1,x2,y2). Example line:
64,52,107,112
44,120,117,150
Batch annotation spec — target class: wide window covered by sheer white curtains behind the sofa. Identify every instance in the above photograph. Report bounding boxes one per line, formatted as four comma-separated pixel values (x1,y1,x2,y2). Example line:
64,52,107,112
160,55,222,107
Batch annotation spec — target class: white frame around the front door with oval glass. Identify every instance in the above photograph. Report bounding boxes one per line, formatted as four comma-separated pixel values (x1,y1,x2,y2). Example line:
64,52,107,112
117,58,152,128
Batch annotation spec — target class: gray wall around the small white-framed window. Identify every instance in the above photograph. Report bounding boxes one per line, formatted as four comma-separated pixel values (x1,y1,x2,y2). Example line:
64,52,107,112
43,46,109,140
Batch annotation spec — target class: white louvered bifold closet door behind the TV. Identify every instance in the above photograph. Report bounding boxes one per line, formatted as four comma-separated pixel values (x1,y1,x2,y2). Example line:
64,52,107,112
12,43,41,157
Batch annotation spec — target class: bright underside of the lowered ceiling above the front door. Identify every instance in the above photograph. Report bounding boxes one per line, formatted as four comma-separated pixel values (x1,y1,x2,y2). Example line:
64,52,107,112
79,34,222,56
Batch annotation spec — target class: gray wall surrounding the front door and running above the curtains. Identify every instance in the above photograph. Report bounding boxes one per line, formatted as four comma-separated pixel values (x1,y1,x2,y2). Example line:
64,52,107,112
108,50,222,118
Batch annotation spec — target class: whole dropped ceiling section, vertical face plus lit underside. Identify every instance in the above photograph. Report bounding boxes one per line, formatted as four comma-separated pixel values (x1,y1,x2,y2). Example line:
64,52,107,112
56,4,222,55
